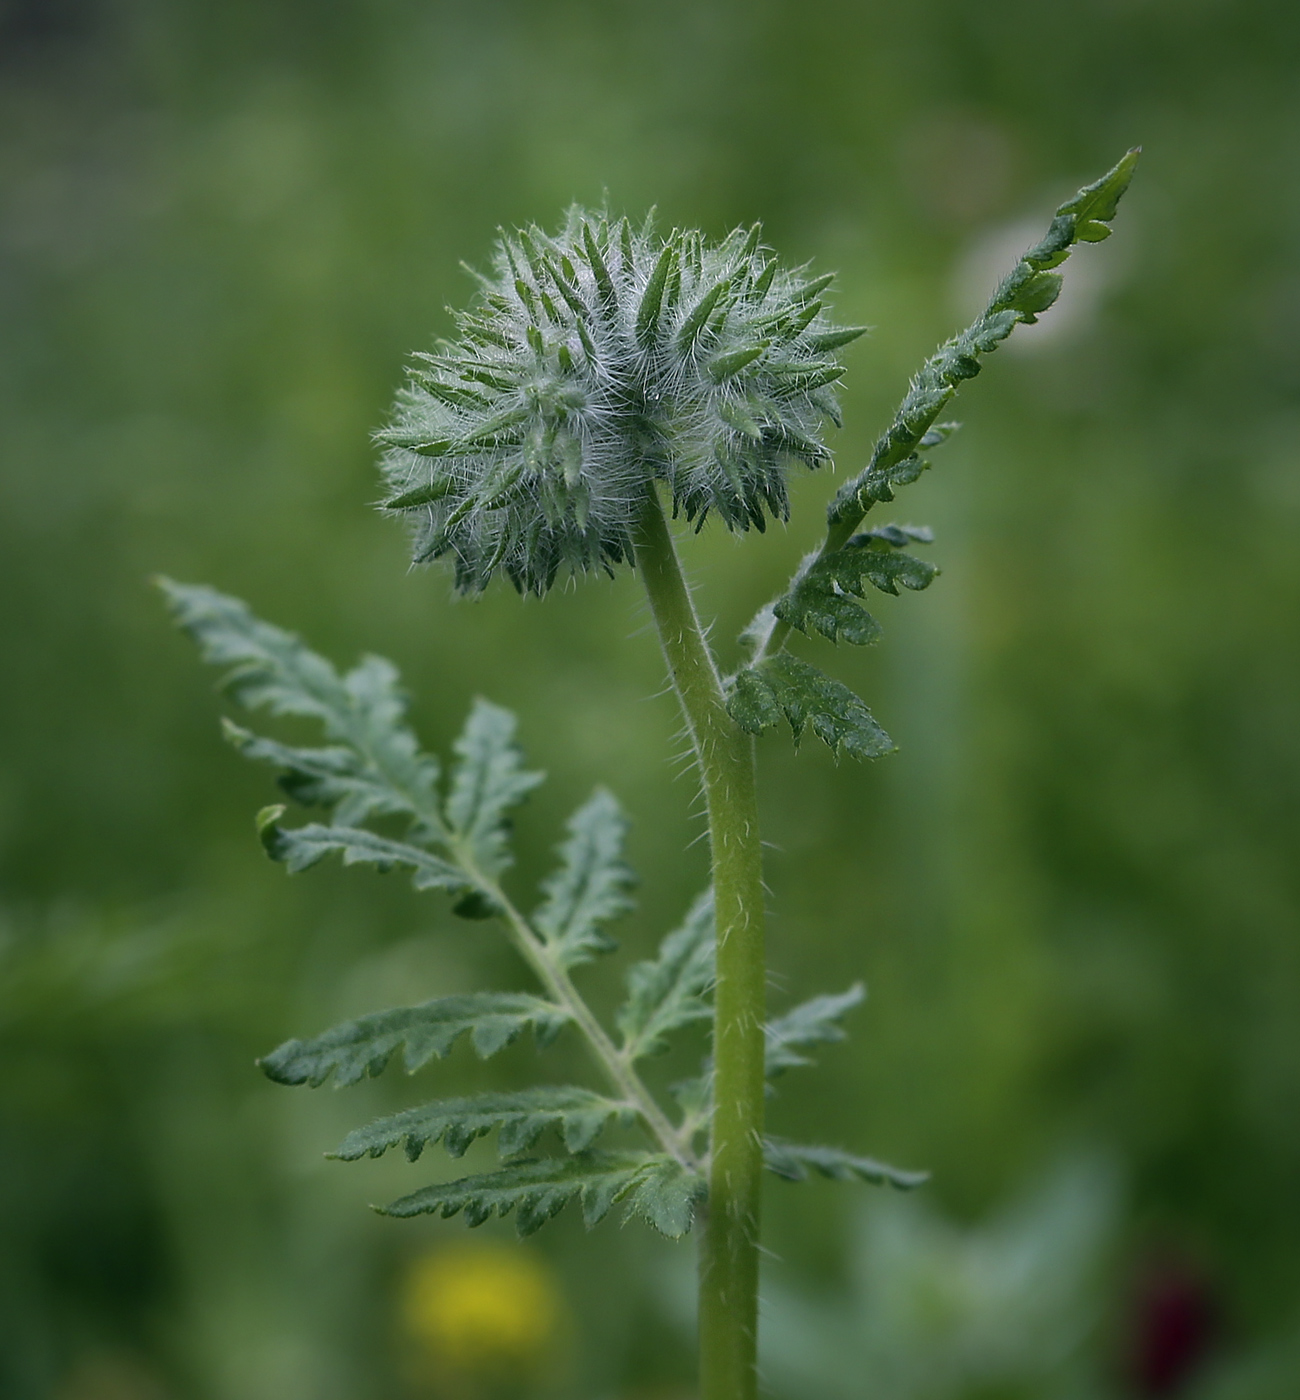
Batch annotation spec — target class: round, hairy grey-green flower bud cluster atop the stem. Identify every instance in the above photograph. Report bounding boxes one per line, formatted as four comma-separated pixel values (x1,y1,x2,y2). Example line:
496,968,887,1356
378,209,862,594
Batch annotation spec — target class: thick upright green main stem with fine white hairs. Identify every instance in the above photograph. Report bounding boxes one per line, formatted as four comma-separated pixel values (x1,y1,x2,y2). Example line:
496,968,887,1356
637,494,765,1400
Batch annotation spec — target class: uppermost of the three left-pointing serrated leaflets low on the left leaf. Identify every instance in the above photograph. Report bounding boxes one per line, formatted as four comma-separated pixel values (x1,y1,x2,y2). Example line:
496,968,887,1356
257,991,570,1088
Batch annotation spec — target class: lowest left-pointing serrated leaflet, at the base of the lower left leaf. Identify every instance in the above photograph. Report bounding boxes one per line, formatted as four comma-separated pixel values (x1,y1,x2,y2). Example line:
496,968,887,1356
379,1152,704,1239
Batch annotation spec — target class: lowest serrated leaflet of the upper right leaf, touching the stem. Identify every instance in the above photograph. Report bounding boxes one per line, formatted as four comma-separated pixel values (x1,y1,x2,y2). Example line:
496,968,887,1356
726,651,894,759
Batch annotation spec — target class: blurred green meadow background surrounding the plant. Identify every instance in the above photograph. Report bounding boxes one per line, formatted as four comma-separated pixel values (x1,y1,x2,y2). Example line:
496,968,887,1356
0,0,1300,1400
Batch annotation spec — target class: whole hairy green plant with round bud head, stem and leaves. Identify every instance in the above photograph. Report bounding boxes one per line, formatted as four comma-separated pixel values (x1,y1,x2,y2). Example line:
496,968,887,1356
162,151,1136,1400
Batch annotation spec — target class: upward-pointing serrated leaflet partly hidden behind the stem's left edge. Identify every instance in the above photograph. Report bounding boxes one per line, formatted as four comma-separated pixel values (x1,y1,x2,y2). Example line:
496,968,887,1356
617,890,714,1061
